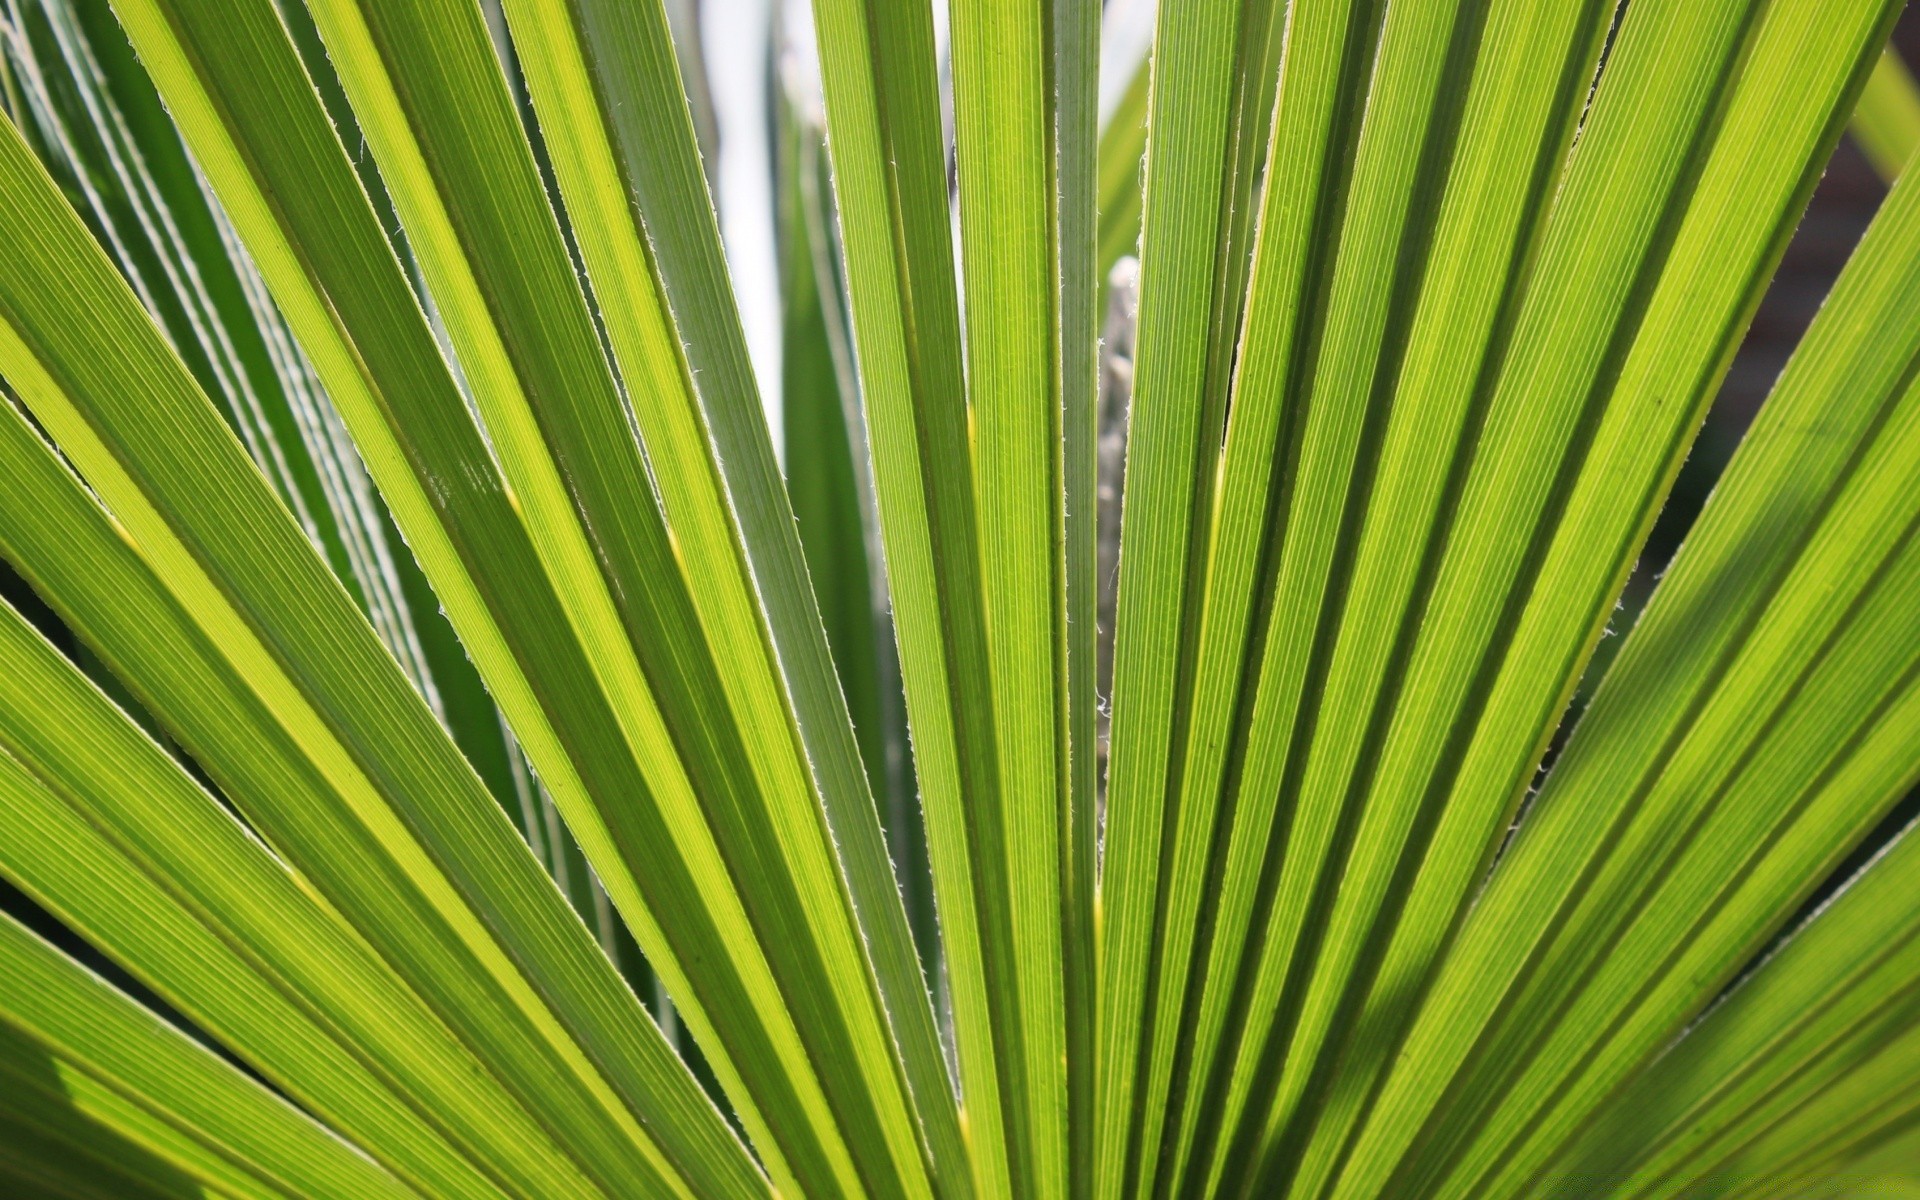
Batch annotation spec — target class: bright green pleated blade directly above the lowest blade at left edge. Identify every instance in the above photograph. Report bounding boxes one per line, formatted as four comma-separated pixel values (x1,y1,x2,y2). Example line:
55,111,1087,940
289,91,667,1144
0,552,675,1192
